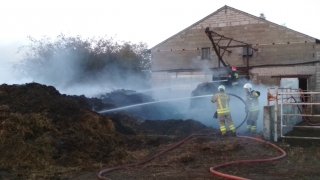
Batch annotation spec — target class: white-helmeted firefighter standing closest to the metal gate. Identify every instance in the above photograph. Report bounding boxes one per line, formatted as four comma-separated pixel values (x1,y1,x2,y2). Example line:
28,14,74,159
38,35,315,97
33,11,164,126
243,83,260,135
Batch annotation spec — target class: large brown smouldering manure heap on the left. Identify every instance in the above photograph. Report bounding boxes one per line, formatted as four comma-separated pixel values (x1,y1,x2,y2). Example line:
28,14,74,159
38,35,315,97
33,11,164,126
0,83,215,179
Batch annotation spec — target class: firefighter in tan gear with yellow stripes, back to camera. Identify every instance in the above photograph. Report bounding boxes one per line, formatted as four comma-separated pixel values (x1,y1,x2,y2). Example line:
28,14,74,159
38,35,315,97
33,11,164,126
211,85,236,136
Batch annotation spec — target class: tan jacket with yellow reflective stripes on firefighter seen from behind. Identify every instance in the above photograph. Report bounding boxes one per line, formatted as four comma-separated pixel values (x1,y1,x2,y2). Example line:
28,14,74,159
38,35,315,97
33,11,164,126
211,92,230,114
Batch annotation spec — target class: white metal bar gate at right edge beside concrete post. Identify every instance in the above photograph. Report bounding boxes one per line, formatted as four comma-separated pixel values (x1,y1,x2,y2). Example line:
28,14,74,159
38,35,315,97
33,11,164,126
268,87,320,141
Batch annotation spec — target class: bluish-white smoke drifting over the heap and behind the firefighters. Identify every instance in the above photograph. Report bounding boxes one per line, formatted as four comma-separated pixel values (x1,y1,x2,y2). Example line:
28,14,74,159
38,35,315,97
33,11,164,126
0,39,300,135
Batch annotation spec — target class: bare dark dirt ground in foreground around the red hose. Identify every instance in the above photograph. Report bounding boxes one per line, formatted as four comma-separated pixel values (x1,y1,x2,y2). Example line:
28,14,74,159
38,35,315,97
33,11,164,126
72,137,320,180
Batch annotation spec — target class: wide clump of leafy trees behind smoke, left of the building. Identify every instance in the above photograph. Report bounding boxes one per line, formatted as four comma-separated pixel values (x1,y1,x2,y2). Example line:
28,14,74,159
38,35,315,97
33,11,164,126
15,34,151,88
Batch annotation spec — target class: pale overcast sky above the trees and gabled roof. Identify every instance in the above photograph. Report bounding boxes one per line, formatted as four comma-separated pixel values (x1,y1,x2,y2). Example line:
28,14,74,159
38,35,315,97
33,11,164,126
0,0,320,83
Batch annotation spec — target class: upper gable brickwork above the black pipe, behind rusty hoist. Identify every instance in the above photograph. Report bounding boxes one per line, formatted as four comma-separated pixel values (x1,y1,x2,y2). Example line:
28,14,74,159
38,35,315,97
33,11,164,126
151,7,320,70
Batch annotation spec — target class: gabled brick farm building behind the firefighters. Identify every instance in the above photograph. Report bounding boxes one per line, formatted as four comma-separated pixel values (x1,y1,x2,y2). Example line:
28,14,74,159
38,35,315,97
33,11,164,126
151,6,320,91
